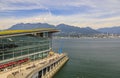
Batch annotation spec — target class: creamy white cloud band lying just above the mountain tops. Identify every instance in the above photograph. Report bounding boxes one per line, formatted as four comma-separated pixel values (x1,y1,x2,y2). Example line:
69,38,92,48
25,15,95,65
0,14,120,29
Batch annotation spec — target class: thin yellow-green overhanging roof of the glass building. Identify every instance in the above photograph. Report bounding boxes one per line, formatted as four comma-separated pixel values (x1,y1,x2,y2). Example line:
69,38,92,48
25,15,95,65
0,28,59,38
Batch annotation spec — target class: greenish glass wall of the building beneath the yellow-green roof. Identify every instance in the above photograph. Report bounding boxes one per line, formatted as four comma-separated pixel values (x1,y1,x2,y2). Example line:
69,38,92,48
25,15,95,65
0,32,51,61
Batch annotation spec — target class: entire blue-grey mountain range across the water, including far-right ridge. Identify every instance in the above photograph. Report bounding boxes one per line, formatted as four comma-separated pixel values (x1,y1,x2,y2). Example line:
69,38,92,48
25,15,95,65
9,23,120,35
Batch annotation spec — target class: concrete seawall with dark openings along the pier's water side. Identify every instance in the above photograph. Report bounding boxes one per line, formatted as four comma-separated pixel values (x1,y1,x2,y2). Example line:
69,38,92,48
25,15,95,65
26,54,69,78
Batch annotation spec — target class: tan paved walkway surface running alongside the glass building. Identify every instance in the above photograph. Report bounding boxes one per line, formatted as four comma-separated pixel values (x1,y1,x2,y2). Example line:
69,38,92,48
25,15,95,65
0,53,64,78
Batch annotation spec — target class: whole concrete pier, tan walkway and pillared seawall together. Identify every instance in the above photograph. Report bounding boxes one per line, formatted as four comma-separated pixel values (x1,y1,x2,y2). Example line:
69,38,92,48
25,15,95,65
0,53,68,78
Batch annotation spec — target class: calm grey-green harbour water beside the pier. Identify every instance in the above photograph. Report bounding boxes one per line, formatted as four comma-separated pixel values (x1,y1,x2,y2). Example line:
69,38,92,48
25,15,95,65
53,39,120,78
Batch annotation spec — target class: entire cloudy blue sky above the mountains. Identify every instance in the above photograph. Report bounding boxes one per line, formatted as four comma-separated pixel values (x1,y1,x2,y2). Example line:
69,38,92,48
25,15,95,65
0,0,120,29
